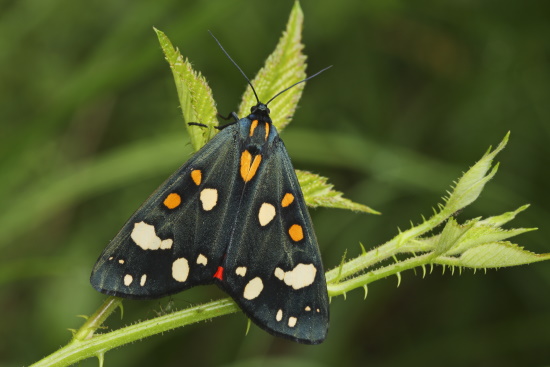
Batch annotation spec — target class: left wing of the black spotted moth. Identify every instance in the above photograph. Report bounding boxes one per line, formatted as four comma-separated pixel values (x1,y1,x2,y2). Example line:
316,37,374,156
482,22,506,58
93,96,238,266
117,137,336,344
90,126,244,299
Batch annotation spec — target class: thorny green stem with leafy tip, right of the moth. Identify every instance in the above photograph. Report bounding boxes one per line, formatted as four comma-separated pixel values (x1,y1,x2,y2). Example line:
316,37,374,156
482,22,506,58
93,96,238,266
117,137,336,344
327,134,550,296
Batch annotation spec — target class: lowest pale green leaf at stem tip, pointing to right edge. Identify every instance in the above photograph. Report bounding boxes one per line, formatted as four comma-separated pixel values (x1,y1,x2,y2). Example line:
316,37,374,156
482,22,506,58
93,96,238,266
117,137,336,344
457,242,550,268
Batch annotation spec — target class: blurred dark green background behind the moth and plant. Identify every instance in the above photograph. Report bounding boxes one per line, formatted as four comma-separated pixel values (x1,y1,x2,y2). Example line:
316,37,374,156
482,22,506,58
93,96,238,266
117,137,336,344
0,0,550,367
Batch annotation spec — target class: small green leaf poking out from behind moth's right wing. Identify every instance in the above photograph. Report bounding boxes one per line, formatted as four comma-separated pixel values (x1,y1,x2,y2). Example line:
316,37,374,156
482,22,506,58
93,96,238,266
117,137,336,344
296,170,380,214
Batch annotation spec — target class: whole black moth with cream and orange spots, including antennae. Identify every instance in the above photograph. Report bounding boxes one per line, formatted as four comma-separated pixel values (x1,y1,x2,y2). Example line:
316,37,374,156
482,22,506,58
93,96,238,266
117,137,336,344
90,32,329,344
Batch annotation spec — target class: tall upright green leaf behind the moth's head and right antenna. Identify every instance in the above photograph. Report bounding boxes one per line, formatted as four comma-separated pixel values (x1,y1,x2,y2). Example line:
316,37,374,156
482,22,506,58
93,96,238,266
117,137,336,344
238,2,306,132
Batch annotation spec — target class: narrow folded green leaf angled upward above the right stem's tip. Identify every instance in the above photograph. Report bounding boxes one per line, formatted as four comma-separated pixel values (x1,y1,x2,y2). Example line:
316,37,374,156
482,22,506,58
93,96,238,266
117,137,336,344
445,133,510,212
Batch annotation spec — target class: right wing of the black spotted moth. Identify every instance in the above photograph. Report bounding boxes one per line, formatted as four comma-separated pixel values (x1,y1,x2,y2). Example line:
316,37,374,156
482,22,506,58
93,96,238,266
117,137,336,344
219,132,329,344
